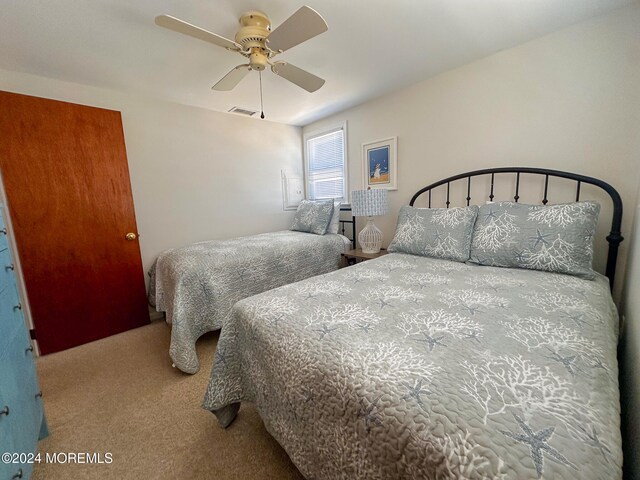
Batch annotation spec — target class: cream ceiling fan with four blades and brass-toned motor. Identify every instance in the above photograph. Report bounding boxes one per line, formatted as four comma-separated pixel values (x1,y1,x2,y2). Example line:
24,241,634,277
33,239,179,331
156,6,328,92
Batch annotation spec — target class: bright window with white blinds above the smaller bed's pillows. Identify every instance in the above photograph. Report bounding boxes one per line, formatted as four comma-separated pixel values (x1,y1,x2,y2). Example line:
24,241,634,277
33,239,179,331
304,124,348,200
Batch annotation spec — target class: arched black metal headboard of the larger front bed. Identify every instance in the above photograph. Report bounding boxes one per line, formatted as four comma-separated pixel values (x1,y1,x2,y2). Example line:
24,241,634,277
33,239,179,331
409,167,624,288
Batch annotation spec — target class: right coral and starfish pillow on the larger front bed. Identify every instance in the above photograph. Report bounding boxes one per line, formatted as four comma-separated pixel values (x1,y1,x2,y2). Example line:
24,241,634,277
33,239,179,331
470,202,600,279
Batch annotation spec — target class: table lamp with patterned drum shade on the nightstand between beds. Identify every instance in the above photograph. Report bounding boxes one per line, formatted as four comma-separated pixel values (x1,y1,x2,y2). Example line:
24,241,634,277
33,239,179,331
351,188,389,253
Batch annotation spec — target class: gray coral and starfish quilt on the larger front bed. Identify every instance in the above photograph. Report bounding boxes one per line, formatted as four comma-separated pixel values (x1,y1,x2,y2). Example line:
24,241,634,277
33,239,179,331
204,254,622,480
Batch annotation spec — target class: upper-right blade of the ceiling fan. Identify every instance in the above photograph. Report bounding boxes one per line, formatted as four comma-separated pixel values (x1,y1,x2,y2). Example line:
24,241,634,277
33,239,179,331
267,5,329,51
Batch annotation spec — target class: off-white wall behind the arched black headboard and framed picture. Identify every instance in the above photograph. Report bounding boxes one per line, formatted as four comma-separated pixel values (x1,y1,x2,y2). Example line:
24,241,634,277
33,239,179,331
303,4,640,292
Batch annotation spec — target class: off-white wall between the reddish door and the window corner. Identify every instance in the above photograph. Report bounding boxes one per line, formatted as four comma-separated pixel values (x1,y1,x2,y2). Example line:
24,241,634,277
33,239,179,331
0,65,302,280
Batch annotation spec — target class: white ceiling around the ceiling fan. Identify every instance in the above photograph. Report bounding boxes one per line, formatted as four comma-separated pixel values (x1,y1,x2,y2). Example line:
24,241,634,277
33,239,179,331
0,0,633,125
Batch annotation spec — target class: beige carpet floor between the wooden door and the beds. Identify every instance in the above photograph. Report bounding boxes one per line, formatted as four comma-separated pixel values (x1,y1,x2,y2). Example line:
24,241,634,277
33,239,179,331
33,322,303,480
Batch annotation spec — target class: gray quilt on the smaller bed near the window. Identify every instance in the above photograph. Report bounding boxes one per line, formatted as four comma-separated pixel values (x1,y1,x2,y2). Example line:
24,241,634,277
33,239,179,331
149,230,345,373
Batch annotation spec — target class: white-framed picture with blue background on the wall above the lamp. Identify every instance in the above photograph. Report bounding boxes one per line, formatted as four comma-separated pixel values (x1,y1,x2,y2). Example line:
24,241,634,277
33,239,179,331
362,137,398,190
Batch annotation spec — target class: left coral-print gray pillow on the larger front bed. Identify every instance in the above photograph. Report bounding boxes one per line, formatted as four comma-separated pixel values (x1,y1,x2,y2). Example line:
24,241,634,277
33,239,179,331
388,205,478,262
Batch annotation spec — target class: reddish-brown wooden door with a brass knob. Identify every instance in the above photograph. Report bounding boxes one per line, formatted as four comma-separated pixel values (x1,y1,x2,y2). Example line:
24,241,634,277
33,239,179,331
0,92,149,353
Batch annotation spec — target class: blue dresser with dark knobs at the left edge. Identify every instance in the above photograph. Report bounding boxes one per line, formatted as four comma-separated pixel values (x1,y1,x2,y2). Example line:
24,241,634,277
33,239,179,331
0,204,48,480
